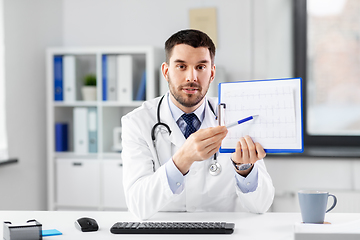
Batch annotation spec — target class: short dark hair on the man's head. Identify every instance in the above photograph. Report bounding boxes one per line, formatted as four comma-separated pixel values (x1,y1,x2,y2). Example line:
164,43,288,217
165,29,215,65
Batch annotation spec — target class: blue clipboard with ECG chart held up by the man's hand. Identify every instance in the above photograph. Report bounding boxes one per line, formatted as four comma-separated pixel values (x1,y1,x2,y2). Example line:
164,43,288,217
218,78,304,153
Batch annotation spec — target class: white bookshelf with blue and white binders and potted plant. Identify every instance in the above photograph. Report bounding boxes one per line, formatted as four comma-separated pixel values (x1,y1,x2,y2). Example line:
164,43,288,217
46,46,164,210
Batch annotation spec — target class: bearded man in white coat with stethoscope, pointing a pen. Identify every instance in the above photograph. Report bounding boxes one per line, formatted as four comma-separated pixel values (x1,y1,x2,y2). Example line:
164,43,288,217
121,30,274,219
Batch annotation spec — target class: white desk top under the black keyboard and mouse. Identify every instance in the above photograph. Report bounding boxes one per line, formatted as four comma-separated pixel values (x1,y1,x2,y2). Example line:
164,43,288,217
0,211,360,240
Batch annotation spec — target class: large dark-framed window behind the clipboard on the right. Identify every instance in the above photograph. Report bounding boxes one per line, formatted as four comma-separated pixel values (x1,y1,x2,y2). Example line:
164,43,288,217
294,0,360,147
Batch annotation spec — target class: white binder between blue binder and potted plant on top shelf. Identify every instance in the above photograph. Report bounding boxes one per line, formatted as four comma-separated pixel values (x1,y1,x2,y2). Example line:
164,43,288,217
63,55,76,102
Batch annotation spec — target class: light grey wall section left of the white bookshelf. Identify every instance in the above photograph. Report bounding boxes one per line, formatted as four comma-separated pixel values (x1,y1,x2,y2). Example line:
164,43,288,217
0,0,63,210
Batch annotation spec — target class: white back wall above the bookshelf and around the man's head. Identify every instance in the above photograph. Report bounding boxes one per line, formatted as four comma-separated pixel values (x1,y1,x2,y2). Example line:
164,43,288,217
64,0,292,81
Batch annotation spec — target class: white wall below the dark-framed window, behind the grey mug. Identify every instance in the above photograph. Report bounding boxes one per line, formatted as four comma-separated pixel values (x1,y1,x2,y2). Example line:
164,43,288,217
267,158,360,212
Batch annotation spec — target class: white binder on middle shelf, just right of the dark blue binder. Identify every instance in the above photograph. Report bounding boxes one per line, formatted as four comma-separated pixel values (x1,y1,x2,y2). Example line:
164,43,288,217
73,107,89,154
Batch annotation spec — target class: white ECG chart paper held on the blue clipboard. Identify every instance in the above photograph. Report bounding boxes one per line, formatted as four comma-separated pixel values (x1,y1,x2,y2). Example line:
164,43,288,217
223,87,296,140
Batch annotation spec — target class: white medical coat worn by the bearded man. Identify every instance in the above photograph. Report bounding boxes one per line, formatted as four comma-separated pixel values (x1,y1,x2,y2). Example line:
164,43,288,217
121,94,275,219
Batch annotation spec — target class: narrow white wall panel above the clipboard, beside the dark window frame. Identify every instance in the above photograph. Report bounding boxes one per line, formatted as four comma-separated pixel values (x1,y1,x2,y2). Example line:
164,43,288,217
251,0,293,79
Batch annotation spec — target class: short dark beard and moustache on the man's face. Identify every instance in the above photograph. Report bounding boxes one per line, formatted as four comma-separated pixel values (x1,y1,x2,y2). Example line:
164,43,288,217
168,76,210,107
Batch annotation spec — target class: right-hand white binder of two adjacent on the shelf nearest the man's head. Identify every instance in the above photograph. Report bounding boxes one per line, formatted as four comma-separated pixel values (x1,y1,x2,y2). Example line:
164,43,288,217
117,55,134,103
